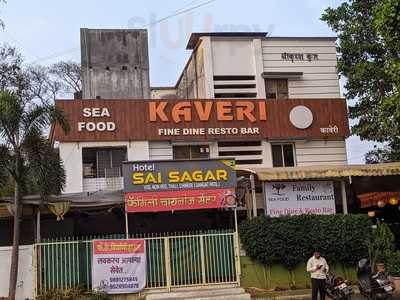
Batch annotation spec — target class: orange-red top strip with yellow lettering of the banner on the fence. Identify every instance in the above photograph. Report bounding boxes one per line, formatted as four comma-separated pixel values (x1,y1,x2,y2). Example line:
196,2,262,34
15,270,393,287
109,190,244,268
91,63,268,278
93,240,144,254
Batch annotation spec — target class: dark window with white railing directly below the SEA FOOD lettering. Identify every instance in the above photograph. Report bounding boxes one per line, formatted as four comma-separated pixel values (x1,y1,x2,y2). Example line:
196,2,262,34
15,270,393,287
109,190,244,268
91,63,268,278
82,148,126,178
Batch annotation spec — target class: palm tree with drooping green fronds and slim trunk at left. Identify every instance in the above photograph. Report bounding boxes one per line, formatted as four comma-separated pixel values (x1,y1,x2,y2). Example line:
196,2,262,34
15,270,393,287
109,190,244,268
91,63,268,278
0,90,69,300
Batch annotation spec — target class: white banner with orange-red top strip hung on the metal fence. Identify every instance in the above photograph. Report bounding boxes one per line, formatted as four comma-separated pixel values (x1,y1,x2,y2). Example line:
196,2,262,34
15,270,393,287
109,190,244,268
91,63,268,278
92,240,146,294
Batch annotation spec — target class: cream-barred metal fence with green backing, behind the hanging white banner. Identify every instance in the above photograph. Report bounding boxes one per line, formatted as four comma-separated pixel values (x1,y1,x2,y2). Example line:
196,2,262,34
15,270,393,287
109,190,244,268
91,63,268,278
35,231,240,291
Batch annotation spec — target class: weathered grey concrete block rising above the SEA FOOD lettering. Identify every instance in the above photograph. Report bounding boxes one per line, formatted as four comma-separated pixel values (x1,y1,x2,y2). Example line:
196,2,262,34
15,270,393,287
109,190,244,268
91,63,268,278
81,28,150,99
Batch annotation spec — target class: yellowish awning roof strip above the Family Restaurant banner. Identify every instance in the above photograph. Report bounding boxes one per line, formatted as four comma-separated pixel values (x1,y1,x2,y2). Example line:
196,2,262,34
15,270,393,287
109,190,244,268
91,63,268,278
242,162,400,181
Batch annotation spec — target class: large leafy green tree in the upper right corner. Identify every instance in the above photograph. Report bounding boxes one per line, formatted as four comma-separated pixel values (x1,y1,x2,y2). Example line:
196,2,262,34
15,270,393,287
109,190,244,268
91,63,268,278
321,0,400,163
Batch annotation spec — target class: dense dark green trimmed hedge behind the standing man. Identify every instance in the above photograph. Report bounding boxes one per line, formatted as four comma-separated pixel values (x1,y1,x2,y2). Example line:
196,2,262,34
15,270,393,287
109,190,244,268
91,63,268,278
239,214,372,270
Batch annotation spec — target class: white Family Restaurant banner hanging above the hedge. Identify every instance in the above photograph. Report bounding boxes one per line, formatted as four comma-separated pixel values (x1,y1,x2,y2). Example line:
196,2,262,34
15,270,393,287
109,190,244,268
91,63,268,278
265,181,335,217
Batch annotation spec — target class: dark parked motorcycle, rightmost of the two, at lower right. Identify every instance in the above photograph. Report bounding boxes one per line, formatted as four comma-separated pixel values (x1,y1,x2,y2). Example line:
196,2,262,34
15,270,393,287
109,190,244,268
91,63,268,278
357,258,394,300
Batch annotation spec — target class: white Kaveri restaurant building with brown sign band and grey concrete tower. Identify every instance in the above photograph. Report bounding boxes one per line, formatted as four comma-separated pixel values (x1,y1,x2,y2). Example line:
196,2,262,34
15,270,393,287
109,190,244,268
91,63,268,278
42,29,349,234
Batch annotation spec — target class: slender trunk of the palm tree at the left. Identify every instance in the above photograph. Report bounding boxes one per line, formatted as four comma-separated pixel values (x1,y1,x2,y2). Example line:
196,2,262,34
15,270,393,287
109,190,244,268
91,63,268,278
8,159,22,300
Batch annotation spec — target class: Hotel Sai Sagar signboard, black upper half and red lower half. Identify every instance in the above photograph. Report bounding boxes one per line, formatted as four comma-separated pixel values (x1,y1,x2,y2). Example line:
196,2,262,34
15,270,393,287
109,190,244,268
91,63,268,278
123,160,236,212
